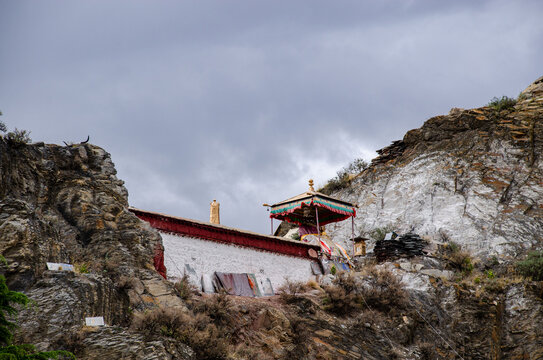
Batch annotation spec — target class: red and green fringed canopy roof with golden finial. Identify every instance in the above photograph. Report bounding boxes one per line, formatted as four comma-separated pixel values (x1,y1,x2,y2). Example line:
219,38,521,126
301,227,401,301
270,180,356,226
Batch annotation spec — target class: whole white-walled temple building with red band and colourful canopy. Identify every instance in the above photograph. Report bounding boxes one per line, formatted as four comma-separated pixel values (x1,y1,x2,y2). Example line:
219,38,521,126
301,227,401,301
130,181,356,296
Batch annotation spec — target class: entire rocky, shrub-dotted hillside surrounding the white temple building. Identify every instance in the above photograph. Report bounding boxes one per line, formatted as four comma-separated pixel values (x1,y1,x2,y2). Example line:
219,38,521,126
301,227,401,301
0,79,543,360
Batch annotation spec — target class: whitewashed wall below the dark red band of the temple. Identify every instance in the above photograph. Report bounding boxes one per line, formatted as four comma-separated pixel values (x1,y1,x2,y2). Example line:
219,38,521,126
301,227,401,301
160,233,315,291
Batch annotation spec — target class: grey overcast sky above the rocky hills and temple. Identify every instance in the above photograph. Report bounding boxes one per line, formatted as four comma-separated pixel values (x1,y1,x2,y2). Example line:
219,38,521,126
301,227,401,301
0,0,543,233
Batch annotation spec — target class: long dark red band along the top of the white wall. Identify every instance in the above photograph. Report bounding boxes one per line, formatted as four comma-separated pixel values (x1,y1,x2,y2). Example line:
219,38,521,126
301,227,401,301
130,208,321,260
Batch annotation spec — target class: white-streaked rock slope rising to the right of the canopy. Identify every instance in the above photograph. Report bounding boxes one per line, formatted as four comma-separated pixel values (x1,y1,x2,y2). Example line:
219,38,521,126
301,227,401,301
329,78,543,259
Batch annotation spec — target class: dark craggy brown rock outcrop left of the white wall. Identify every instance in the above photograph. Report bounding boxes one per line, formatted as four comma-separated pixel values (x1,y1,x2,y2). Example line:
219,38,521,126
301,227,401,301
0,139,189,359
